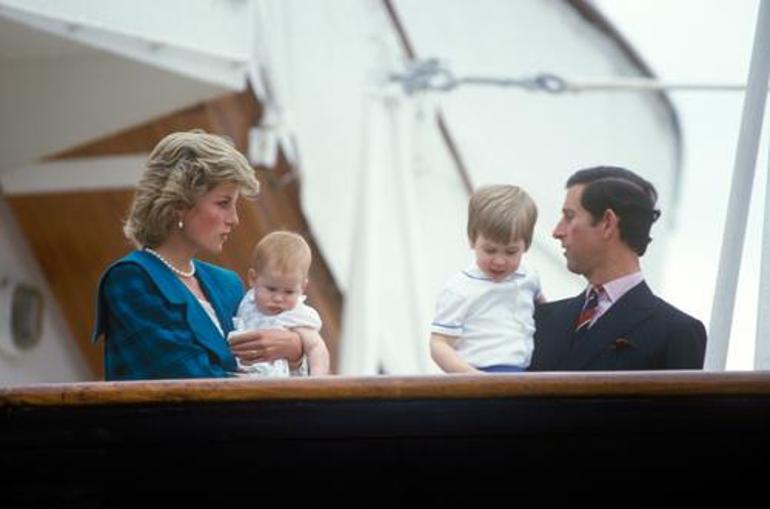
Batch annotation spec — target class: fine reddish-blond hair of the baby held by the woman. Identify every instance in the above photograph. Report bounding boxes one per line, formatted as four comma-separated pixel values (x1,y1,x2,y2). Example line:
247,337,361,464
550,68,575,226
252,230,313,277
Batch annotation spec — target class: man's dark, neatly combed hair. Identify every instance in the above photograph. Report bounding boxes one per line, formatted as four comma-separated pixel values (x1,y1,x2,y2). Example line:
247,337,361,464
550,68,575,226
567,166,660,256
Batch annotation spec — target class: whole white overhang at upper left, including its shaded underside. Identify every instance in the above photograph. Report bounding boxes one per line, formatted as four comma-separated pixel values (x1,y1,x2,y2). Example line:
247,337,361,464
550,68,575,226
0,0,252,172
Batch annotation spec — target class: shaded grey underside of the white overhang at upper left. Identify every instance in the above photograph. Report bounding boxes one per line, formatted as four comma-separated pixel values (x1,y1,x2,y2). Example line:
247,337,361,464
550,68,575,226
0,53,226,171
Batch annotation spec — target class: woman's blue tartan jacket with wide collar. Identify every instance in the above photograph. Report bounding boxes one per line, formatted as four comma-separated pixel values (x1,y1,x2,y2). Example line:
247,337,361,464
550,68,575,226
92,251,244,380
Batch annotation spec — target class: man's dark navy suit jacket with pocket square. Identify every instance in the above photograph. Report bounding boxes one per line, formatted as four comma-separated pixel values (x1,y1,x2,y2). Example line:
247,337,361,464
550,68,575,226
529,282,706,371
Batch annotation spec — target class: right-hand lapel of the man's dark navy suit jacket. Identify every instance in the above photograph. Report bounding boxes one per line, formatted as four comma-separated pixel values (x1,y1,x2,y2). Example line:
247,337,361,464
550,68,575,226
567,282,655,370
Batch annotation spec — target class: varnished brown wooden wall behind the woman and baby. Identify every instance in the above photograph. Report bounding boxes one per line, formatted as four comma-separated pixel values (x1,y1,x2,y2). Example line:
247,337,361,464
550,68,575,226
8,90,342,378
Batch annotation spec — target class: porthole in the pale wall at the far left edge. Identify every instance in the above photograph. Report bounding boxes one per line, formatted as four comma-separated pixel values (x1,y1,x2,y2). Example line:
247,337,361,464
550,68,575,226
0,279,43,356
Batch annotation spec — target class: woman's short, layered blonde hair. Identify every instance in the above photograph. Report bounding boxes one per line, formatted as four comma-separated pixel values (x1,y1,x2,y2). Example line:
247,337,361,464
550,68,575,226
123,129,259,248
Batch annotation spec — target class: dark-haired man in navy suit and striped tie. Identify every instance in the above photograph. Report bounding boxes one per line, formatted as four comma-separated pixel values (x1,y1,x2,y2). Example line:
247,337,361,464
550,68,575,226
530,167,706,371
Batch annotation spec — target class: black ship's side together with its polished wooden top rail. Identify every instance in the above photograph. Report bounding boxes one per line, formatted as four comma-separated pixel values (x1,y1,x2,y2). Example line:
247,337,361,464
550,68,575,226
0,372,770,507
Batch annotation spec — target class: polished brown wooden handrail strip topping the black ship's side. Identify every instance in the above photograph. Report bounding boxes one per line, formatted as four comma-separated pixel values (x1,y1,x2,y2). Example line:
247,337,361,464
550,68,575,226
0,371,770,407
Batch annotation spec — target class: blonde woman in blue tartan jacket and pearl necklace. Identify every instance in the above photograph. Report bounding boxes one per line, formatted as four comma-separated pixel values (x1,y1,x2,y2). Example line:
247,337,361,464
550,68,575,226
93,130,302,380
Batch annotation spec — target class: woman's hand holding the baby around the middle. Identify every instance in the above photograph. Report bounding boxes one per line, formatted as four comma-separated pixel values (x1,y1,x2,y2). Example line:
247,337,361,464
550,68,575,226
228,329,303,364
